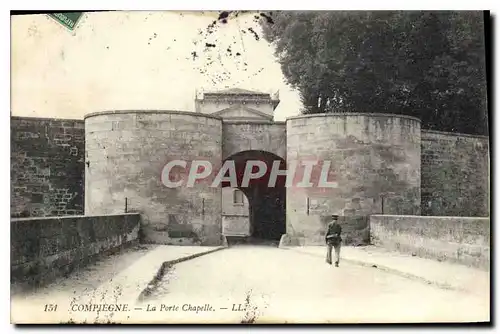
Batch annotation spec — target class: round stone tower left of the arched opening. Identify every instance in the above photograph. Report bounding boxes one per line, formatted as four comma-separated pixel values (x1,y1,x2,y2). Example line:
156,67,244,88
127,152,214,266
85,110,223,246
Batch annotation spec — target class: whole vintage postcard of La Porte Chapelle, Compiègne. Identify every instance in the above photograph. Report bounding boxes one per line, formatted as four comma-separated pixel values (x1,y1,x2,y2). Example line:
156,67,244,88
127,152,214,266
10,11,491,324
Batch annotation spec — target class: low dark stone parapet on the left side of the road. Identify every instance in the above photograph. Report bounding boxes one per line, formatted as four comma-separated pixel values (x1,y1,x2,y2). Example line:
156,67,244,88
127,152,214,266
10,213,140,286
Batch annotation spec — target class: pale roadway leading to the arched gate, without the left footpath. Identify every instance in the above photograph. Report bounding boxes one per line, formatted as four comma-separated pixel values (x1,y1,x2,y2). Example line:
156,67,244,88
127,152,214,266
143,246,489,323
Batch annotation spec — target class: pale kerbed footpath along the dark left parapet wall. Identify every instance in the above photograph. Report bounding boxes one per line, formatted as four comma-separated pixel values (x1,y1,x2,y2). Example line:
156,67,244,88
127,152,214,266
11,245,224,323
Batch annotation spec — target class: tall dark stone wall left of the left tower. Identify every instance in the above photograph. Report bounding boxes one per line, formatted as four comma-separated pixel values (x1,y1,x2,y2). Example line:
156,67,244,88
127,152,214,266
10,117,85,217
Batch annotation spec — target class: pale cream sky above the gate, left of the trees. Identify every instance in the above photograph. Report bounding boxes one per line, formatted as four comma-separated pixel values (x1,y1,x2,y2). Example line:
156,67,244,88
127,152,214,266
11,11,301,121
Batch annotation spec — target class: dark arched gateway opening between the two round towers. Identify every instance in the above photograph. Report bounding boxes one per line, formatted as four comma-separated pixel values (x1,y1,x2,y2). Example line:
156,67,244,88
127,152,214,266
222,150,286,243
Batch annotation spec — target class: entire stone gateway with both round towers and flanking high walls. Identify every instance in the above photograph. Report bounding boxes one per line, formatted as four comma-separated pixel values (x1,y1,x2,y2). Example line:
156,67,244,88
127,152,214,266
11,89,489,245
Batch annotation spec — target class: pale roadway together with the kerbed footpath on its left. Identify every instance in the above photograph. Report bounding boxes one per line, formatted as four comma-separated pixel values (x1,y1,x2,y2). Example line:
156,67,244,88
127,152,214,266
12,245,489,323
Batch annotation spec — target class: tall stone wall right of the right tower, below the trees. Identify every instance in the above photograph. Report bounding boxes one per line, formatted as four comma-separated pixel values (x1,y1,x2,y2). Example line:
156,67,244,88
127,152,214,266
421,131,490,217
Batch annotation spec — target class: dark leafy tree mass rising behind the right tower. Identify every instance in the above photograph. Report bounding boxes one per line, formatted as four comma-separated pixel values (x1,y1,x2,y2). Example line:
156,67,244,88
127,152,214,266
261,11,487,134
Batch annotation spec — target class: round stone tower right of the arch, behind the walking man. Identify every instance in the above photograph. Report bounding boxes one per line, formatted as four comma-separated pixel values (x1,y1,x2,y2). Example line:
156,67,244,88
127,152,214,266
286,113,420,241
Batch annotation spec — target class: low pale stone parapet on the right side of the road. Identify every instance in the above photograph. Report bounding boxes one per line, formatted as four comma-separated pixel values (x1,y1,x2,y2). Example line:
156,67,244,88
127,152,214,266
370,215,490,269
